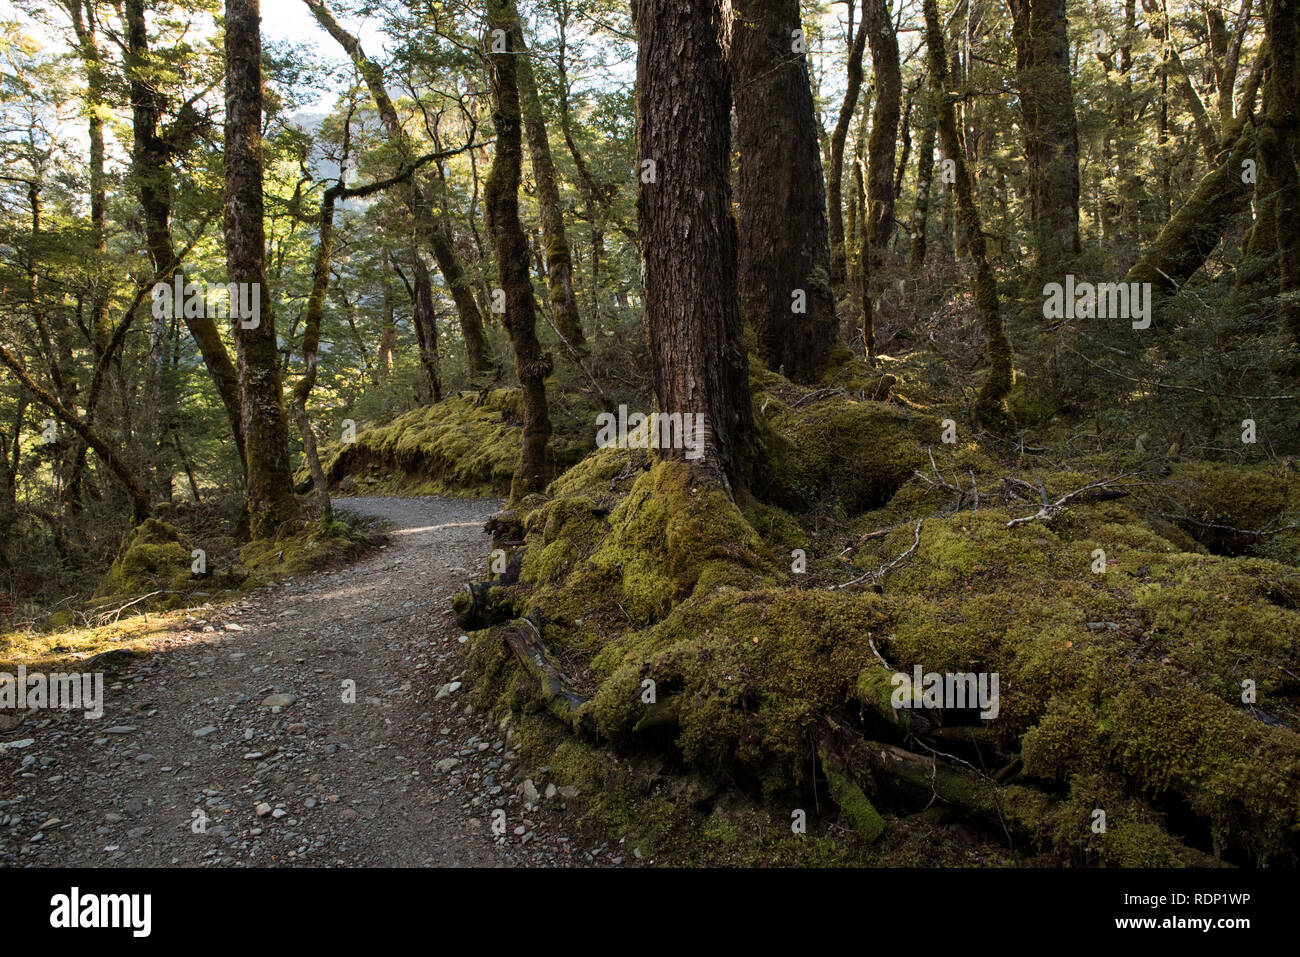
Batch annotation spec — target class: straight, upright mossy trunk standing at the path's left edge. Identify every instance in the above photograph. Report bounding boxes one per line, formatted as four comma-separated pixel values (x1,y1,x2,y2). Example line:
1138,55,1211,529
224,0,298,538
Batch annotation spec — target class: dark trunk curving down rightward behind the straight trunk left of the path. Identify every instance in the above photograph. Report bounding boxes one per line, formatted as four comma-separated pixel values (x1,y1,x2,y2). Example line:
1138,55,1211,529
124,0,245,471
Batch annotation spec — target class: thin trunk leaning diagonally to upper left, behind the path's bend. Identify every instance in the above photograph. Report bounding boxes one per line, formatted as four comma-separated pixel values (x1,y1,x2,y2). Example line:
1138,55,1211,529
303,0,493,374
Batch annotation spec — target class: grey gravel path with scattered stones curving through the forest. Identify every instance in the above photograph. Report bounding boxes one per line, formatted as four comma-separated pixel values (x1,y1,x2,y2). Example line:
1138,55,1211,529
0,497,634,867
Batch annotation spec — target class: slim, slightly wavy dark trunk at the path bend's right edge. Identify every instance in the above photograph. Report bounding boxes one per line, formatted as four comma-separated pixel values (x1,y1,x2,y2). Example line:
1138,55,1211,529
484,0,551,501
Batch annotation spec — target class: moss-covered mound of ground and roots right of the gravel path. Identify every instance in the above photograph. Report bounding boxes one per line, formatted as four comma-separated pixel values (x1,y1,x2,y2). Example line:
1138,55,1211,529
439,356,1300,866
